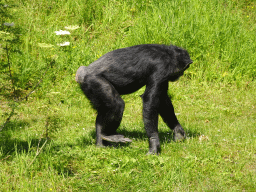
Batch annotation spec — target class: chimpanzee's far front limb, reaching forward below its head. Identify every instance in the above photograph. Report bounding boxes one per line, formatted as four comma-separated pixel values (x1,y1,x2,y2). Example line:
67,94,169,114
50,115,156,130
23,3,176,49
159,94,185,141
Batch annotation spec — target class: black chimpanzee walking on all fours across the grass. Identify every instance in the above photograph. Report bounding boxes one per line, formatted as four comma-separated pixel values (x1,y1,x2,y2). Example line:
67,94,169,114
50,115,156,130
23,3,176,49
76,44,192,154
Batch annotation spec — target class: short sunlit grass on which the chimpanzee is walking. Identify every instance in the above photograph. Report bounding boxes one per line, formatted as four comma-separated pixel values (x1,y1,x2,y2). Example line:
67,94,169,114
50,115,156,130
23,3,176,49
0,79,256,191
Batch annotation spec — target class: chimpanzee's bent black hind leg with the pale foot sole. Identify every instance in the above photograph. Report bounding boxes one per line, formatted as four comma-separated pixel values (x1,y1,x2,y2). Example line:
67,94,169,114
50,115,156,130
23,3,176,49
80,75,131,146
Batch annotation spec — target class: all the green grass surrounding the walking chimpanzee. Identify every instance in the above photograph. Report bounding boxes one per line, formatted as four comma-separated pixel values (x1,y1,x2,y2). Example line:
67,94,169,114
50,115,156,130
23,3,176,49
0,0,256,191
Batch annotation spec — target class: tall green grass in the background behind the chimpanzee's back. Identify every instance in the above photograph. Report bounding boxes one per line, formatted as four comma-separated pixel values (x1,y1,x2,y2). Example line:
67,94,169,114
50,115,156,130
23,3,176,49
1,0,256,96
